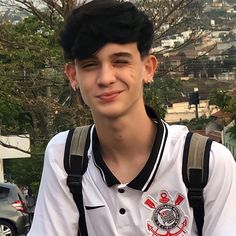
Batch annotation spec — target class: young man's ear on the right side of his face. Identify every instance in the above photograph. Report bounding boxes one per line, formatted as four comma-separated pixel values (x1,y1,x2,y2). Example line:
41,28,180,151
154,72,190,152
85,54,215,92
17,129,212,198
144,55,158,84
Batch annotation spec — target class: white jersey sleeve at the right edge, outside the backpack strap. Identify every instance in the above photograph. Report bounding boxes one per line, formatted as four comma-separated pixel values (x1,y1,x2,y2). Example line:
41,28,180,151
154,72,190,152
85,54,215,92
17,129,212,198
203,142,236,236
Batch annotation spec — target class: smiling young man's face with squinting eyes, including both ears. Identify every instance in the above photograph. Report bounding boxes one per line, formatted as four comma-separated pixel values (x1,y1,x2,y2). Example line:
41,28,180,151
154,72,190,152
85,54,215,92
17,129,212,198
66,43,156,118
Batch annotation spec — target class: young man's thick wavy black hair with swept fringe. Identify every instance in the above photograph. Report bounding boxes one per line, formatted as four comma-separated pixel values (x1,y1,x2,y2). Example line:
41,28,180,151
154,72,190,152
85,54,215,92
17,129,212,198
60,0,154,60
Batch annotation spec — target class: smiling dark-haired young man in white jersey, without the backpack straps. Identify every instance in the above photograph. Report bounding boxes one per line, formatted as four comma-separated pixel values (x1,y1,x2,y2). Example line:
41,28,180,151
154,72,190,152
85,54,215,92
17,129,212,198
28,0,236,236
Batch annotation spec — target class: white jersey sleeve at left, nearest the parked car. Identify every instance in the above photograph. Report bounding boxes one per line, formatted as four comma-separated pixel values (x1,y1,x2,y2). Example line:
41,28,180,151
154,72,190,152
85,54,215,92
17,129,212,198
27,132,79,236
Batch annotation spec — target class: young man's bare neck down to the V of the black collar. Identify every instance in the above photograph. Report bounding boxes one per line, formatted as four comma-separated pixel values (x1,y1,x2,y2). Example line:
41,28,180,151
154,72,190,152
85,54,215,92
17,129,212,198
93,105,157,183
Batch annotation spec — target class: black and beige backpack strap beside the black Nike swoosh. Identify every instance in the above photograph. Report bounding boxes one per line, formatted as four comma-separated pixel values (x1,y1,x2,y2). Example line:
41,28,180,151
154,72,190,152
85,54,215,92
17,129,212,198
64,126,90,236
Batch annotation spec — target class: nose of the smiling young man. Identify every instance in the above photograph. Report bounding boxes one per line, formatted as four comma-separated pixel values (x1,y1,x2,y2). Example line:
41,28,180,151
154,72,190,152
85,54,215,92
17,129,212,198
97,63,116,86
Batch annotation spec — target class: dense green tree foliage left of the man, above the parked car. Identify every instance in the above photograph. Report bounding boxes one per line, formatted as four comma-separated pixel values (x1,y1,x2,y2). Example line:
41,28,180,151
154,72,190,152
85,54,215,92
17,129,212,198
0,16,74,189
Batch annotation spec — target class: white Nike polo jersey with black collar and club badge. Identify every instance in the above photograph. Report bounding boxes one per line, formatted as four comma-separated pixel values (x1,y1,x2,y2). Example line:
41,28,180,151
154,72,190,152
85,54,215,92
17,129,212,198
28,120,236,236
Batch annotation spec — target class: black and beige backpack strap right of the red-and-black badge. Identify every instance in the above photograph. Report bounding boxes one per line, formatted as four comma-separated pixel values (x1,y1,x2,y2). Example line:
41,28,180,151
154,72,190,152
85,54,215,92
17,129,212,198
182,132,212,236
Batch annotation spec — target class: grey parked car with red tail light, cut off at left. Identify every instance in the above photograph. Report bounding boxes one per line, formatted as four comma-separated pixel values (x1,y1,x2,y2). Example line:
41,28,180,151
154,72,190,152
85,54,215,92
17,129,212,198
0,183,30,236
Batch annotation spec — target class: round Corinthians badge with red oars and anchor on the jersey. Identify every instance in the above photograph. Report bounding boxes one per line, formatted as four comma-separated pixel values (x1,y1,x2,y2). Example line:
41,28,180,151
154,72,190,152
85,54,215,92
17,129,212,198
144,191,188,236
